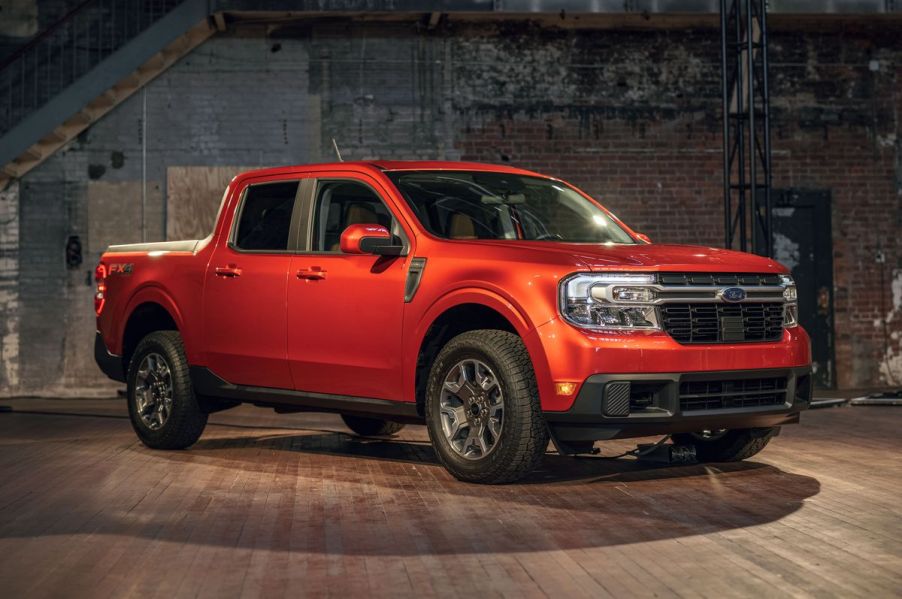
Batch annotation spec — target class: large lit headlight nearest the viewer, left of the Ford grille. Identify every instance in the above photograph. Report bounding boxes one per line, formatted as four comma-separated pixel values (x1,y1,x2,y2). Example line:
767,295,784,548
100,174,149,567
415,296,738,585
560,273,661,330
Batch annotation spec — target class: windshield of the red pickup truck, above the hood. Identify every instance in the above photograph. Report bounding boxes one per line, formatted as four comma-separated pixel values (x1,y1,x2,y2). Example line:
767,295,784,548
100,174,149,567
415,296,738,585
386,171,636,243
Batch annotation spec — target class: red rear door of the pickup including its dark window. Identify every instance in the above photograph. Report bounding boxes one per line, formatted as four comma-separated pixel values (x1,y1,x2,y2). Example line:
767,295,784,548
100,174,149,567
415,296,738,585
203,178,303,389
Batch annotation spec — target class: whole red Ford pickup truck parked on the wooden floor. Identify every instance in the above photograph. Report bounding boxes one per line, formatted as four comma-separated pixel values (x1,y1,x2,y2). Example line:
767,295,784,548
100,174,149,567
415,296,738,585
95,161,811,483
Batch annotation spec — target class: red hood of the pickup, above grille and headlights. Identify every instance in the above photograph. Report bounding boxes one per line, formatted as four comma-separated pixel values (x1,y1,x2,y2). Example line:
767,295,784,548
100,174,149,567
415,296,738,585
462,241,788,274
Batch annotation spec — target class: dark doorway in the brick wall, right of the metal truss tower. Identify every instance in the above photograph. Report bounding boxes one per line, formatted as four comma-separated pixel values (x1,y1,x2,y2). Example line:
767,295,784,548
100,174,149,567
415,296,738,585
771,189,836,389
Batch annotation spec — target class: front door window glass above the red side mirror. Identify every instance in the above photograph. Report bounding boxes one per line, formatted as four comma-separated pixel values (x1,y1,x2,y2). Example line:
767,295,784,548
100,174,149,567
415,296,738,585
313,181,396,252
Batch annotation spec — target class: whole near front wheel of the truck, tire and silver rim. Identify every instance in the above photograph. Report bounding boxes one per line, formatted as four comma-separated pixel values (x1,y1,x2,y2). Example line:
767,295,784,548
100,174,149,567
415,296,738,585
426,330,548,484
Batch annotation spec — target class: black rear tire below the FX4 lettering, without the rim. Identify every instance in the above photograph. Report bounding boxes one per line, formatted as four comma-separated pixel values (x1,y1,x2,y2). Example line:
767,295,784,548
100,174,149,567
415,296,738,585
127,331,207,449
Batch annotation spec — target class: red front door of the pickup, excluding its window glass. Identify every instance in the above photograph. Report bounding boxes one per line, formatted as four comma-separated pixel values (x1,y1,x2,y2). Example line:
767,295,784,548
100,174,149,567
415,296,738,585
288,173,409,400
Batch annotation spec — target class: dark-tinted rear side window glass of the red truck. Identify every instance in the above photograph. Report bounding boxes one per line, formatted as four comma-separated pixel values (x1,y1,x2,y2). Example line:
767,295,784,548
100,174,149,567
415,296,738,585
235,181,298,251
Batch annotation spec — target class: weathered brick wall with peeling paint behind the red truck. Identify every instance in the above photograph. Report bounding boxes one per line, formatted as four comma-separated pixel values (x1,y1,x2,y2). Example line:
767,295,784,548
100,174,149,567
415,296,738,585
0,18,902,392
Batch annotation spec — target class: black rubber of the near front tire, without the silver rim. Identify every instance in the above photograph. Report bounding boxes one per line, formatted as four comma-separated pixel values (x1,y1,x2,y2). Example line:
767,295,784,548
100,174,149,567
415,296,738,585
425,329,548,484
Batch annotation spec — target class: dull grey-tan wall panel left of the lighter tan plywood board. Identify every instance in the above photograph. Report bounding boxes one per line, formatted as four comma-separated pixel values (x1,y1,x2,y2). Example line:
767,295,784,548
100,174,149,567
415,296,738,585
88,181,163,254
